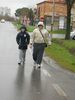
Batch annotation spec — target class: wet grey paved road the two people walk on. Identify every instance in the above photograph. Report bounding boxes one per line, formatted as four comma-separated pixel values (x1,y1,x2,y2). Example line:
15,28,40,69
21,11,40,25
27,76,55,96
0,22,75,100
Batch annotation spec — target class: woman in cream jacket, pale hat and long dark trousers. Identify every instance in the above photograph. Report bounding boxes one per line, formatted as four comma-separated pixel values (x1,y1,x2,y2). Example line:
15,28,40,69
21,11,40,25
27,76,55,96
30,22,51,68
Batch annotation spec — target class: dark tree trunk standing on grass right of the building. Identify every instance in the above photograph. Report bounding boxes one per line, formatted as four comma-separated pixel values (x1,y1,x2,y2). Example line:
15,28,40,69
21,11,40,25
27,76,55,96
65,6,71,40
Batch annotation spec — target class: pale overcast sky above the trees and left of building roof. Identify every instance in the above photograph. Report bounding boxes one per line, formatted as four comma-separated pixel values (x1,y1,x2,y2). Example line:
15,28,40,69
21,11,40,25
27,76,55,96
0,0,44,14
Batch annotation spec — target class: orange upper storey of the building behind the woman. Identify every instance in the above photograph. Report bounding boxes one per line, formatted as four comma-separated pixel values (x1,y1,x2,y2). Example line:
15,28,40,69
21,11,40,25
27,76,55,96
37,0,67,17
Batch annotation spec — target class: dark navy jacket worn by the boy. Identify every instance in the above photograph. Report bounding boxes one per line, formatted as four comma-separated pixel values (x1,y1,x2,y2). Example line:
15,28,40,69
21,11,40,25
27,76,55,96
16,32,30,50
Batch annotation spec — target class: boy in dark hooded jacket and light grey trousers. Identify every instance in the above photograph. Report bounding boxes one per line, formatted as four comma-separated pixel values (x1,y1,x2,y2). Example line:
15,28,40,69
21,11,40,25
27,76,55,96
16,26,30,65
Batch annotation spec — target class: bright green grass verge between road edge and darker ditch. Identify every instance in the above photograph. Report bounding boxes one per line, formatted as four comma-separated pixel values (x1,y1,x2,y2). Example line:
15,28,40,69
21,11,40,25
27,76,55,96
46,43,75,72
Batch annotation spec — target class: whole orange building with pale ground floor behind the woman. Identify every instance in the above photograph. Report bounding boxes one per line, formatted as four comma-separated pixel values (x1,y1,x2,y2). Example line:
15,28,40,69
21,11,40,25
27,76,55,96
37,0,67,29
